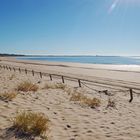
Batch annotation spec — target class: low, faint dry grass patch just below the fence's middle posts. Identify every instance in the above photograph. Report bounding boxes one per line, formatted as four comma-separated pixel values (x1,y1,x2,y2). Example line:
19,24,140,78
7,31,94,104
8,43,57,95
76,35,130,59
43,83,66,90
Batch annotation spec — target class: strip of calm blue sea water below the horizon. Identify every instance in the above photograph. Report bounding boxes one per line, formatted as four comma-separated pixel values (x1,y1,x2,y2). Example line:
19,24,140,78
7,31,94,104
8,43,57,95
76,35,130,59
17,56,140,65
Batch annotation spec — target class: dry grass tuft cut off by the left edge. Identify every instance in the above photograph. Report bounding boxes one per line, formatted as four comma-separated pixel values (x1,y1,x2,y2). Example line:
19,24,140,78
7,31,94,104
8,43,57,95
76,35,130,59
0,92,17,101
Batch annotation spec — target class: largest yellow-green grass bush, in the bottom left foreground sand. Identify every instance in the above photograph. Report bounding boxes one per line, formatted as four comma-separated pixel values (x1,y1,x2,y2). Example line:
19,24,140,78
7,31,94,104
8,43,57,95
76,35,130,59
13,111,49,136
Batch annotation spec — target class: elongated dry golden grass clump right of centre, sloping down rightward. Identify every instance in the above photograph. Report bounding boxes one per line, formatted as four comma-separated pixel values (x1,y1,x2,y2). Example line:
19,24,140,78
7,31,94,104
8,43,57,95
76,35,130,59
70,93,101,108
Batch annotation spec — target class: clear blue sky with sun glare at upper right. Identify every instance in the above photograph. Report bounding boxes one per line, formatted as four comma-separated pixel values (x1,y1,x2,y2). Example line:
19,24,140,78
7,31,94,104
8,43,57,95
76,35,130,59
0,0,140,55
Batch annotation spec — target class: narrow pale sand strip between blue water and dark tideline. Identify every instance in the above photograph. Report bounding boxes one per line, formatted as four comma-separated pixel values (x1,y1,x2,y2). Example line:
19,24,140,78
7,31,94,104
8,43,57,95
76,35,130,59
0,57,140,73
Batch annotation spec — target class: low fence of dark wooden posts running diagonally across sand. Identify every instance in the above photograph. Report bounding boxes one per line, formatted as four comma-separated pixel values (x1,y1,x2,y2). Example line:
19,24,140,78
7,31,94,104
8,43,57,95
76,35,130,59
0,64,140,102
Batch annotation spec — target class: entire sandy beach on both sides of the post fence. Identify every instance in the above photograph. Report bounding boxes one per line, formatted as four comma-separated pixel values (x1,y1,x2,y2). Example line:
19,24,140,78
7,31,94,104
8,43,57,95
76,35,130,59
0,58,140,140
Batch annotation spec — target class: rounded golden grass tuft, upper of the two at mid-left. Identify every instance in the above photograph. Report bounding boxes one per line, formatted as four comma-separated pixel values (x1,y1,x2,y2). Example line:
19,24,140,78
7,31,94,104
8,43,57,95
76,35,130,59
17,81,39,92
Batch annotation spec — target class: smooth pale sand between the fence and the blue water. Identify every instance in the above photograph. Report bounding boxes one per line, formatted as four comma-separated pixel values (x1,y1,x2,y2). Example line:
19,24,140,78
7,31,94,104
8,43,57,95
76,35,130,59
0,57,140,83
